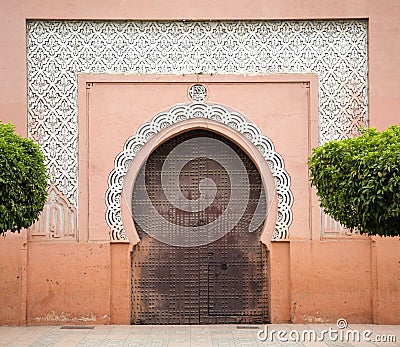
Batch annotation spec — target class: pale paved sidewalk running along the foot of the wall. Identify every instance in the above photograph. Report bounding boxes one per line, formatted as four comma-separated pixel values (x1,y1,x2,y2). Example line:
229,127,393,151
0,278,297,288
0,323,400,347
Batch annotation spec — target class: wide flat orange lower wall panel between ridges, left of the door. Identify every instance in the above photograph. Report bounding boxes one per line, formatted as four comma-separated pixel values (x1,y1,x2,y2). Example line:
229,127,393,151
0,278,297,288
27,241,111,325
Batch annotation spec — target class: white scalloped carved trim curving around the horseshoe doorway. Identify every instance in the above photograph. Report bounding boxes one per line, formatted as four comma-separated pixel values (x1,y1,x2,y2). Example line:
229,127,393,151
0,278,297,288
105,103,293,240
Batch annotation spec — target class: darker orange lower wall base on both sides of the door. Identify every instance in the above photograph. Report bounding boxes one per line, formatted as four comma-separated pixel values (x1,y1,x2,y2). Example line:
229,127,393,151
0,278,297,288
0,234,400,325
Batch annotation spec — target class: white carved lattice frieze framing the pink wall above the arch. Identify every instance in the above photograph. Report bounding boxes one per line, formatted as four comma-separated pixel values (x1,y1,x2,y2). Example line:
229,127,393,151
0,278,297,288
27,20,368,238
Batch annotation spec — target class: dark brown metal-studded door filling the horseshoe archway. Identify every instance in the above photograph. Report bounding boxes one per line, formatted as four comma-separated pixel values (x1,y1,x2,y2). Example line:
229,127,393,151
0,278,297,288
131,130,269,324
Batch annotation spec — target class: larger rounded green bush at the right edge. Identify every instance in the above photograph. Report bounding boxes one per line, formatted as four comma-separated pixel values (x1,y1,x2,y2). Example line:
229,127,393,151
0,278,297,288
308,126,400,236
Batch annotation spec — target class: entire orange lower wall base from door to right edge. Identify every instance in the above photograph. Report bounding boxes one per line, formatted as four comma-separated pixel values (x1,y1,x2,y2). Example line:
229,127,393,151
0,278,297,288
270,237,400,324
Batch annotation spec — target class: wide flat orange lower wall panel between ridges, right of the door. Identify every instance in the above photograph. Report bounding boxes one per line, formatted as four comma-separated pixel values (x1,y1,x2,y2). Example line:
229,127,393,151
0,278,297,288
290,239,372,323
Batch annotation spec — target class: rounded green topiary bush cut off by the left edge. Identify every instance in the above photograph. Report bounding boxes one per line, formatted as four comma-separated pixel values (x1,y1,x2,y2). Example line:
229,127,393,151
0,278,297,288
0,122,47,235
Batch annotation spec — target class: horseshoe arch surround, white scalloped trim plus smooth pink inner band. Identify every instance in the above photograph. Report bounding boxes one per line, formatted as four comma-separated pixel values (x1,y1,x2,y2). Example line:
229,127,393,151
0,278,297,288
105,102,293,243
